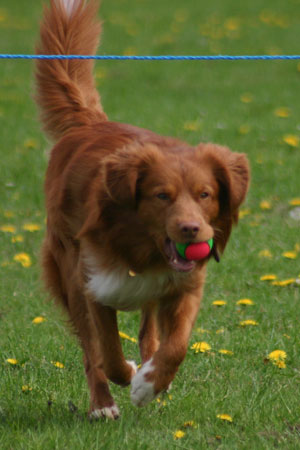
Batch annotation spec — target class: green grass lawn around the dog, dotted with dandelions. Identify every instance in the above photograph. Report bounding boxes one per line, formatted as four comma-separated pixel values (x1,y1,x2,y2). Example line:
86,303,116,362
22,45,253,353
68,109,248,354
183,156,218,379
0,0,300,450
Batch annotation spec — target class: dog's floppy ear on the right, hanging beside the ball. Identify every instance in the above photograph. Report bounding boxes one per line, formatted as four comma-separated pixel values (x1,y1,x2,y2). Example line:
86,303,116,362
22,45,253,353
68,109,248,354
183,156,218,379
200,144,250,252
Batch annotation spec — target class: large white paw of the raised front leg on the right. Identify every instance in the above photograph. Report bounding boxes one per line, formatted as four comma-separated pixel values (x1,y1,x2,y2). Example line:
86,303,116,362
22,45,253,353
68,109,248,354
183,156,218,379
130,359,155,406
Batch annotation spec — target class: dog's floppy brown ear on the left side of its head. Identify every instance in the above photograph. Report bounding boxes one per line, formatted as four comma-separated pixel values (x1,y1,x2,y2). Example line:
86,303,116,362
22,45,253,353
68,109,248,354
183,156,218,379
102,144,164,208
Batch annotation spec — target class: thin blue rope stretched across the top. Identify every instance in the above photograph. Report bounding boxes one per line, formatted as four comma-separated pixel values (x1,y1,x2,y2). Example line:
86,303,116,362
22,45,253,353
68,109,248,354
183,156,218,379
0,53,300,61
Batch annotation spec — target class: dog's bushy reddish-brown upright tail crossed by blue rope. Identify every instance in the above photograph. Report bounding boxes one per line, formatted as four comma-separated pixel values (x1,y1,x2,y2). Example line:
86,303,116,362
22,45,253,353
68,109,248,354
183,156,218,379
36,0,106,139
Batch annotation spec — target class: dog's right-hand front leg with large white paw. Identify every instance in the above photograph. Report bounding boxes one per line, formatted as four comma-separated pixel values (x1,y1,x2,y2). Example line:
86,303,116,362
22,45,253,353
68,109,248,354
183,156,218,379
131,289,202,406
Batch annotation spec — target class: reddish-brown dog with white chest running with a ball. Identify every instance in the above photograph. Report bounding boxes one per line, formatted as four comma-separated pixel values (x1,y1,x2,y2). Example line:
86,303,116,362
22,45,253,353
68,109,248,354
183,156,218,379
36,0,249,419
